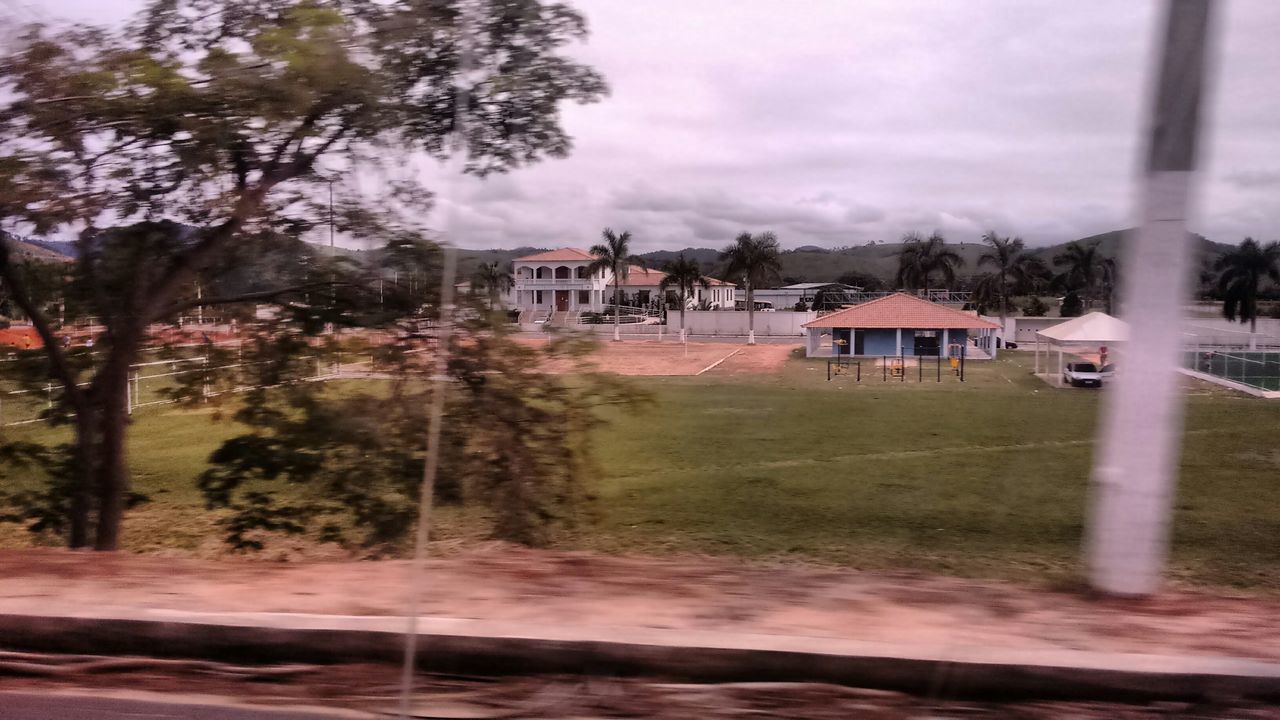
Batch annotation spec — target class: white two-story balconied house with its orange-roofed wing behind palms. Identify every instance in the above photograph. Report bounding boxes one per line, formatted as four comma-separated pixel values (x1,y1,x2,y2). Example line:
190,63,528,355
509,247,735,314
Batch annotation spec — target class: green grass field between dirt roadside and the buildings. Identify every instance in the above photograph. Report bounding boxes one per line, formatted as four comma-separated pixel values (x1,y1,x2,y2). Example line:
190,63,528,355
0,354,1280,591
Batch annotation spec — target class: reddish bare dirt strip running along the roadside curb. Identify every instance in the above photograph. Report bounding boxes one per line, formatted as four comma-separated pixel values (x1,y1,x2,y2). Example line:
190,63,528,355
0,544,1280,661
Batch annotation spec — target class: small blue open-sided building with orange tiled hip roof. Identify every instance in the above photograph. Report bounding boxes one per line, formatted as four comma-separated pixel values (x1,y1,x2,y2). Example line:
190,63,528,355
803,292,1000,359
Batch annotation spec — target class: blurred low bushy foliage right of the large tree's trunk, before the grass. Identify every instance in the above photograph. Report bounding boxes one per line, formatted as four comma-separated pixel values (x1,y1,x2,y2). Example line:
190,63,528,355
200,318,644,550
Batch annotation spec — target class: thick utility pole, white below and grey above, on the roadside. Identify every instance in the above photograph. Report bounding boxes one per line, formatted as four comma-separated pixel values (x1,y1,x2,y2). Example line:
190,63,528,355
1085,0,1212,596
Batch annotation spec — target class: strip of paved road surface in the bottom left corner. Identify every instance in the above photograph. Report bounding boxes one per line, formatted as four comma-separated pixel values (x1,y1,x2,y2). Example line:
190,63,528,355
0,693,372,720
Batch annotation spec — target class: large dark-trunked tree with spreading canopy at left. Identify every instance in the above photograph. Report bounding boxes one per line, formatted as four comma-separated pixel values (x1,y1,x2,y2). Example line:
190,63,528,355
0,0,605,550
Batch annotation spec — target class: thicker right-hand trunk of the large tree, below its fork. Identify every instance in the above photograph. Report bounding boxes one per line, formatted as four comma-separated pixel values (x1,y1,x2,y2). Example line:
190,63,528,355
93,360,129,551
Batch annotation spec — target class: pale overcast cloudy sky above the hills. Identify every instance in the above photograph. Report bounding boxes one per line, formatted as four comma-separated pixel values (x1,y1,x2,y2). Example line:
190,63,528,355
14,0,1280,250
